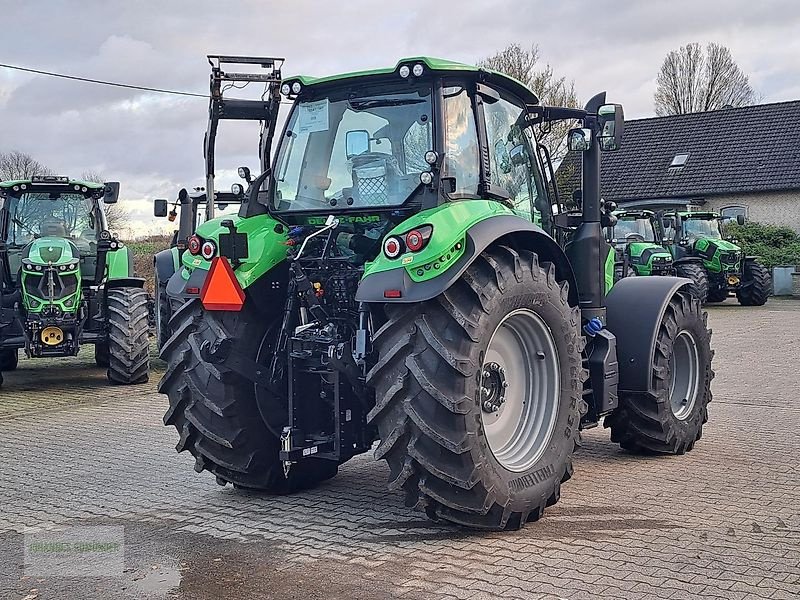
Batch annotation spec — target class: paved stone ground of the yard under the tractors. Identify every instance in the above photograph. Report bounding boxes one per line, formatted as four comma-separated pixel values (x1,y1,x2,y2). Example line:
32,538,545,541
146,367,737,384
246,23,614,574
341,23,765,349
0,300,800,600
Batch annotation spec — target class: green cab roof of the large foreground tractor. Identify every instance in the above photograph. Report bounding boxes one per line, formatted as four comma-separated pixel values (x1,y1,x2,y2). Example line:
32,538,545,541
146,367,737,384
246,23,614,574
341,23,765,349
284,56,539,104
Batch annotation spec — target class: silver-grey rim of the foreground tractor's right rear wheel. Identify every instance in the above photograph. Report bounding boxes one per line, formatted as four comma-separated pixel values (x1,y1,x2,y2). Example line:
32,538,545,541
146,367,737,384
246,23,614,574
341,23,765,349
481,309,561,472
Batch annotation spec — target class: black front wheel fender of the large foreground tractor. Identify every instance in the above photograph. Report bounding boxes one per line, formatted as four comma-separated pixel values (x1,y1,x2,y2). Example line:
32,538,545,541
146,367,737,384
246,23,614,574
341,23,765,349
606,277,692,393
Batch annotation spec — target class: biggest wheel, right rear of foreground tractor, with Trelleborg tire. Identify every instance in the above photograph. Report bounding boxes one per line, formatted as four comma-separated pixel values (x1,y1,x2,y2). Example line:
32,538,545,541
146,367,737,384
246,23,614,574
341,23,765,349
367,247,583,529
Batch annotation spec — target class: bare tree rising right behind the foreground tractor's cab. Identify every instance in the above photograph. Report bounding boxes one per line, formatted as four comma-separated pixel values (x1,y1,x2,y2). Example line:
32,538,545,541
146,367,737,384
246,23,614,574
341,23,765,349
478,44,580,164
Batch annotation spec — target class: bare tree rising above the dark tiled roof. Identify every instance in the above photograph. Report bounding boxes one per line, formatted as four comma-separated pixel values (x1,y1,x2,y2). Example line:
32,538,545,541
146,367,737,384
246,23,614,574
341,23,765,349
653,43,758,116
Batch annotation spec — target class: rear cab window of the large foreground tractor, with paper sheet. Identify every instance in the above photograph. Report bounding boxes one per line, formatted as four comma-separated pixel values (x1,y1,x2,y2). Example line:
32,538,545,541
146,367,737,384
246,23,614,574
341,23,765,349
273,84,433,212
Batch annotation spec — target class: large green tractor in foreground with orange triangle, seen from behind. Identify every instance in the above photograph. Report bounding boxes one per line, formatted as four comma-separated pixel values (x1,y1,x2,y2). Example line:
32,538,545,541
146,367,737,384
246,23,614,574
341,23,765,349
159,56,712,529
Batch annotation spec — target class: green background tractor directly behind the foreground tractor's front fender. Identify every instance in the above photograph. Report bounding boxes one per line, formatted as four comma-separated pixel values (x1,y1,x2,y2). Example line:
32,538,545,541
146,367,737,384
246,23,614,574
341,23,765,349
606,209,708,303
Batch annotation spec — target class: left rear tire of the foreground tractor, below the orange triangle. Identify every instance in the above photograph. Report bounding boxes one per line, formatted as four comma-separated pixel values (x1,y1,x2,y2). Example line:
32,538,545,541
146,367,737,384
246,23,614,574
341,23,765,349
158,300,338,494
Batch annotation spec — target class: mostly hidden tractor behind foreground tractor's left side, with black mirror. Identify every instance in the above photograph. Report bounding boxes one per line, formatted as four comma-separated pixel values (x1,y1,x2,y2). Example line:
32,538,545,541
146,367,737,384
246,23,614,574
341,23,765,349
153,186,244,349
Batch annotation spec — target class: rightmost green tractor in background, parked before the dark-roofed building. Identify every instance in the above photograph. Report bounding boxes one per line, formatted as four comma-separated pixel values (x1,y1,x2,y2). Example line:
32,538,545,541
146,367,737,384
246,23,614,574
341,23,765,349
662,211,772,306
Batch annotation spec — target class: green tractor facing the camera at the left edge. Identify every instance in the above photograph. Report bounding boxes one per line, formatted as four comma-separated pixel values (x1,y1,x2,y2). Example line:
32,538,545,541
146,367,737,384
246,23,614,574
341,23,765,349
0,176,149,384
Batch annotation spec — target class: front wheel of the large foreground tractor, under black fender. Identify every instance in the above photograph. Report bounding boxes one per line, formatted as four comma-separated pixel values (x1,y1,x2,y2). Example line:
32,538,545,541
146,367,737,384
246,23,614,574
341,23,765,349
605,293,714,454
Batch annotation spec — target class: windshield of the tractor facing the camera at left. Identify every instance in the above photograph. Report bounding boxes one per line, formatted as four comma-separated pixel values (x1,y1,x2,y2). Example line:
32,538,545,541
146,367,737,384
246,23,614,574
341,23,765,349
6,192,98,251
